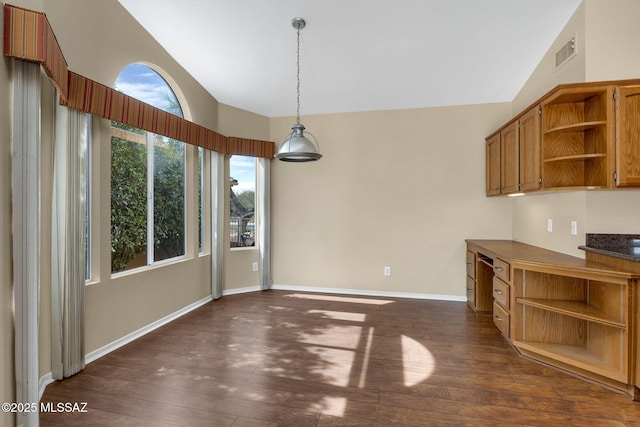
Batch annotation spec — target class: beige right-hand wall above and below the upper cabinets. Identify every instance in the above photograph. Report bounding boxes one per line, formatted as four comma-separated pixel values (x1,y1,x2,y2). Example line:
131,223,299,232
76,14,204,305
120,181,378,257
513,0,640,257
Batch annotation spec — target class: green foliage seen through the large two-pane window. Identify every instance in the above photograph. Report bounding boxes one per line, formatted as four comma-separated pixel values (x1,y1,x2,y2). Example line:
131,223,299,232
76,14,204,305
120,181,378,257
111,124,185,272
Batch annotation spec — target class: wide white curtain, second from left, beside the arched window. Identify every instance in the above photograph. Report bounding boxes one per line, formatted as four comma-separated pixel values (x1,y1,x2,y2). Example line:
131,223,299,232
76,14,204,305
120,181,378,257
51,106,89,380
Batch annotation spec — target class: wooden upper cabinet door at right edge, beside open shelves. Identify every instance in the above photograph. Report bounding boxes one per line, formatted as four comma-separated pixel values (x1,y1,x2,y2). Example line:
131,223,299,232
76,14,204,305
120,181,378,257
616,86,640,187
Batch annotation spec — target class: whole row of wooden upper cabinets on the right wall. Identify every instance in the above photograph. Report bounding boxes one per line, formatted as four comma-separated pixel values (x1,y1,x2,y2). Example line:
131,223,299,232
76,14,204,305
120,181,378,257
487,79,640,196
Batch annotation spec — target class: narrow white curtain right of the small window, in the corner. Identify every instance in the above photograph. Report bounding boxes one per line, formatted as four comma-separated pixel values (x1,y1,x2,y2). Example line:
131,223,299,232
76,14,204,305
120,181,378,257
257,158,271,291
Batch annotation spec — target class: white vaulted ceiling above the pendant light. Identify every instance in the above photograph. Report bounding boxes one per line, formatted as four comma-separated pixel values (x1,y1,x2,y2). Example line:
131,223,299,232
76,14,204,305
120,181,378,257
118,0,581,117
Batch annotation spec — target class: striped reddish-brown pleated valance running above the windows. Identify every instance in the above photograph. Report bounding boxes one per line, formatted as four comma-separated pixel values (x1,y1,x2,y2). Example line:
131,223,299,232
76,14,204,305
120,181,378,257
4,4,275,159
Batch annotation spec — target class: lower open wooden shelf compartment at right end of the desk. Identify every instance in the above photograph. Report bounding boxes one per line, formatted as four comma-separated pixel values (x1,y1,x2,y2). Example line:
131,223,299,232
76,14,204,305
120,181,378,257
513,270,632,388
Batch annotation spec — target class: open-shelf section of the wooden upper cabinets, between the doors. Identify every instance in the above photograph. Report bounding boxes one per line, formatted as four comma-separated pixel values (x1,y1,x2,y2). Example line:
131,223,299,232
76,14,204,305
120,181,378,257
542,86,615,189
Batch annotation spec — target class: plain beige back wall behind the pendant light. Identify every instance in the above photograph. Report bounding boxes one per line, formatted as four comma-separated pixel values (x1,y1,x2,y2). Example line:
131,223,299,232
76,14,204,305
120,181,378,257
271,103,512,297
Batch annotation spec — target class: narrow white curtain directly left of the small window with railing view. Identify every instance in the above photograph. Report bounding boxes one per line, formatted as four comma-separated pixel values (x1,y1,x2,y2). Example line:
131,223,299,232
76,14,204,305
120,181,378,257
211,151,229,299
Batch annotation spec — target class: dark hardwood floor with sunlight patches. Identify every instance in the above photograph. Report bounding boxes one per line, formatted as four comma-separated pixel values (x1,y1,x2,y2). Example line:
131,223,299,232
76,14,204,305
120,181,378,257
40,291,640,427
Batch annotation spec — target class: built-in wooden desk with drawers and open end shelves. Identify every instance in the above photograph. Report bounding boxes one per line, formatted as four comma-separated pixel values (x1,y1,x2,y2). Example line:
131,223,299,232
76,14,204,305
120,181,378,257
466,240,640,400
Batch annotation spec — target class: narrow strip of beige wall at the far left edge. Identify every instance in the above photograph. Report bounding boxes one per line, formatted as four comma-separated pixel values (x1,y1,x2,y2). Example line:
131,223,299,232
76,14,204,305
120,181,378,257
0,4,15,426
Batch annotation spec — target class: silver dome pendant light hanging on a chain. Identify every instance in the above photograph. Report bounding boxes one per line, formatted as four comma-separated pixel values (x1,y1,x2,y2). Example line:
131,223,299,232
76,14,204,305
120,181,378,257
276,18,322,162
